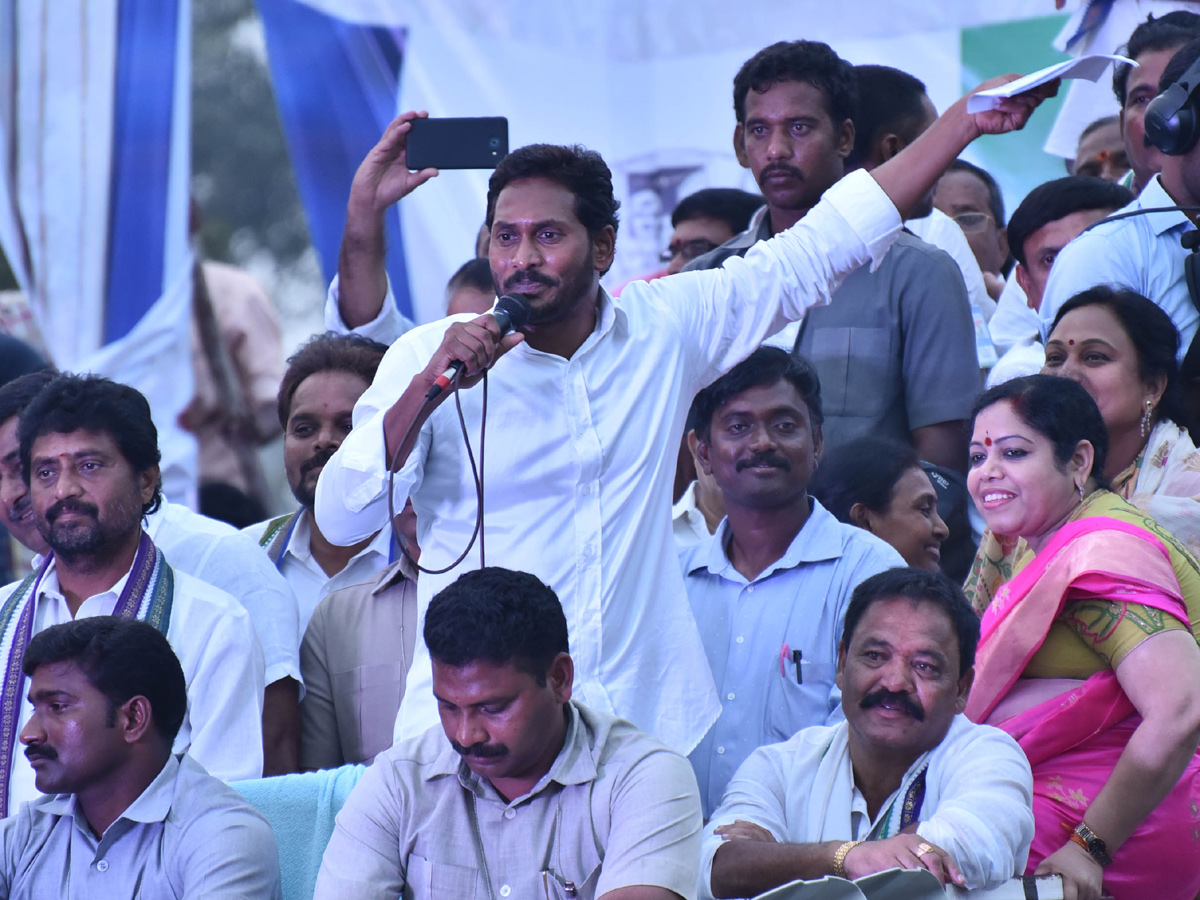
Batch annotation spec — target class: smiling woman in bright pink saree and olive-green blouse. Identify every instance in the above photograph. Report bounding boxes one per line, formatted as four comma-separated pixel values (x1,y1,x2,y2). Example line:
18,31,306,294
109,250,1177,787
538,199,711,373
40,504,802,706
966,376,1200,900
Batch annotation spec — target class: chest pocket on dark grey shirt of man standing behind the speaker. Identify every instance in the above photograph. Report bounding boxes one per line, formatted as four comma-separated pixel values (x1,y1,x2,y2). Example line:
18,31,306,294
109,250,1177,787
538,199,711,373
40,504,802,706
800,328,894,416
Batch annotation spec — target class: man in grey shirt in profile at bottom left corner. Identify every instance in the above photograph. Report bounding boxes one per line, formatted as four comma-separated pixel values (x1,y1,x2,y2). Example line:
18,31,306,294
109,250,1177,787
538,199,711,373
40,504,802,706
0,616,282,900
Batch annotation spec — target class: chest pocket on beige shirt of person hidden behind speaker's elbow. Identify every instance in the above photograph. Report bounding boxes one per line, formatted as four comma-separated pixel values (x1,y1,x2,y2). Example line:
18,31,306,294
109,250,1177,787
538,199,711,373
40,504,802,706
330,661,406,762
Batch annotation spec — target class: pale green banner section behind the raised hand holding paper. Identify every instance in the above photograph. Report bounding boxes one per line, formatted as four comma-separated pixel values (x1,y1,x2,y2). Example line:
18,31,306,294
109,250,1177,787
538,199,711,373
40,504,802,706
962,16,1075,216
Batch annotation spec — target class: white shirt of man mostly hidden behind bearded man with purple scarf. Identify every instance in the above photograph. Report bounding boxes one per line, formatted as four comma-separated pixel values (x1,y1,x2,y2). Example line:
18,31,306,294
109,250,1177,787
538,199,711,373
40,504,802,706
145,498,301,684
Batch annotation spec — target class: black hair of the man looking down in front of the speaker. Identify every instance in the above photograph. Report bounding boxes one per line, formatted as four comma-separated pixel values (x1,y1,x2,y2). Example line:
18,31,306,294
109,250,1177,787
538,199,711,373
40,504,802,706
425,566,570,685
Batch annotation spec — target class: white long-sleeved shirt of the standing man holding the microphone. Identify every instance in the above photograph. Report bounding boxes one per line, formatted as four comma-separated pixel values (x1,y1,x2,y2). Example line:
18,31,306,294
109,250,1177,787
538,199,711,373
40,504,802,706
316,173,900,752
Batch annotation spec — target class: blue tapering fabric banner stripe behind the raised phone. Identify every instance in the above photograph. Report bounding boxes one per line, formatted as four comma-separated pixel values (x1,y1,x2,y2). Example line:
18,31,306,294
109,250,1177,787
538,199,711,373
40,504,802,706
258,0,413,317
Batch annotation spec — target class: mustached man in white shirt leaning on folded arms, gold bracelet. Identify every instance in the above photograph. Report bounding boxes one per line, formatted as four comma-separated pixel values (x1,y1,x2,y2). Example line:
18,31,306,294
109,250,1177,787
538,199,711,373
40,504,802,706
700,569,1033,898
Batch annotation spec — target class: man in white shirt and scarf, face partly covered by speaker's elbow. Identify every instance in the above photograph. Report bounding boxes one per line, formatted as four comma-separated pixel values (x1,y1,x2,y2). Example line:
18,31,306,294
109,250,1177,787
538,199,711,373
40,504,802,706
242,334,392,635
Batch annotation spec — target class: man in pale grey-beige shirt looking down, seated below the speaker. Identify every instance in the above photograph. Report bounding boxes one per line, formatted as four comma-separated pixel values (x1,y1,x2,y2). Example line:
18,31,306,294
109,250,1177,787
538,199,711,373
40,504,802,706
314,568,701,900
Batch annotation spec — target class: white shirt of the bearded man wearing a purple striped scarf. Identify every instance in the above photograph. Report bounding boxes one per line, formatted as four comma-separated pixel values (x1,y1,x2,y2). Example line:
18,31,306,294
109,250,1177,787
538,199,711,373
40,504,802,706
0,553,265,811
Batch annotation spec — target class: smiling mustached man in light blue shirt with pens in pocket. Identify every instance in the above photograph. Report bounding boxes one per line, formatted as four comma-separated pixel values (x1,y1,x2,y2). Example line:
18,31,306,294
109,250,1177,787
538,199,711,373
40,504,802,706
680,347,904,816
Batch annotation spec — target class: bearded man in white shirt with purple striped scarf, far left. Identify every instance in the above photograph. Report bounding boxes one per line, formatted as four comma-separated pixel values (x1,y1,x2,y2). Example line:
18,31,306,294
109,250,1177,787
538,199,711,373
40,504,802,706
0,374,265,811
